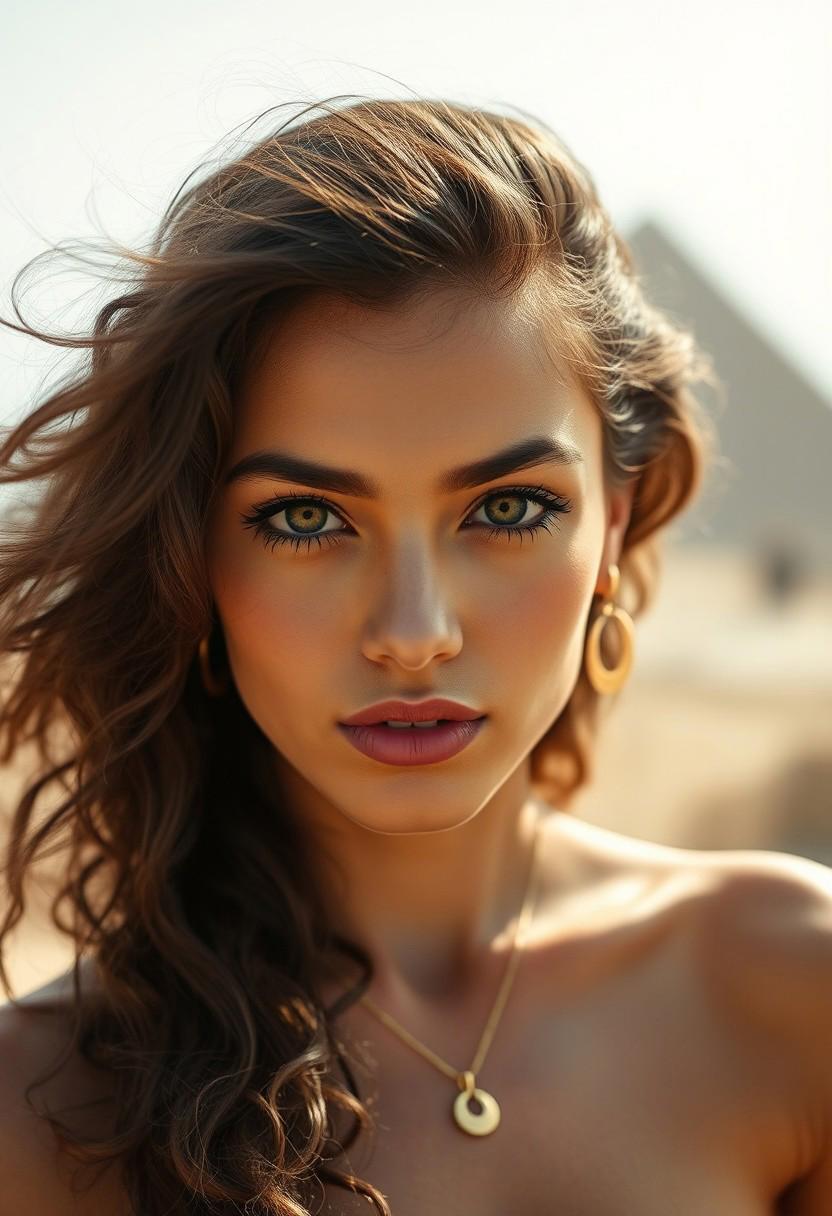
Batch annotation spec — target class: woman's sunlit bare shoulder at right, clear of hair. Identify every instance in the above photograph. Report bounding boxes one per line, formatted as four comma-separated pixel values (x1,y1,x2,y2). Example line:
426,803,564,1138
558,818,832,1216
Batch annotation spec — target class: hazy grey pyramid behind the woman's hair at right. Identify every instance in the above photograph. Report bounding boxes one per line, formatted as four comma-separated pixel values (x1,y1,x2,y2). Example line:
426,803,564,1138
628,221,832,585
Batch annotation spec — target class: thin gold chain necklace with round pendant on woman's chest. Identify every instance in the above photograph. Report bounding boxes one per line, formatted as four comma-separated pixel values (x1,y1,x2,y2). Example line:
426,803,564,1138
359,814,543,1136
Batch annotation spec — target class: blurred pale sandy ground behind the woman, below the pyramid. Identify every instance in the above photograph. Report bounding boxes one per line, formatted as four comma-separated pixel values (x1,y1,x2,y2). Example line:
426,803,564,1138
0,552,832,996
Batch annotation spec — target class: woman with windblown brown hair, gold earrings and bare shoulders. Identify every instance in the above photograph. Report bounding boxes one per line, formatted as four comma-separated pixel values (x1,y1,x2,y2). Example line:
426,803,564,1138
0,100,832,1216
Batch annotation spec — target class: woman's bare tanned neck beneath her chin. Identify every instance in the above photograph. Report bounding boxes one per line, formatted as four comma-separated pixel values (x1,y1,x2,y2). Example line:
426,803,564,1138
272,766,545,1004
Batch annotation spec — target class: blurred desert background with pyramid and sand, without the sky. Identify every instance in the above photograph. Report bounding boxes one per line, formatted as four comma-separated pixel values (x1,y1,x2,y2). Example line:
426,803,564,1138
0,220,832,993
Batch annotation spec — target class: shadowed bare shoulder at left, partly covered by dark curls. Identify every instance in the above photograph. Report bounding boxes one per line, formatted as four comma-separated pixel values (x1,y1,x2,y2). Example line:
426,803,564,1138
0,973,129,1216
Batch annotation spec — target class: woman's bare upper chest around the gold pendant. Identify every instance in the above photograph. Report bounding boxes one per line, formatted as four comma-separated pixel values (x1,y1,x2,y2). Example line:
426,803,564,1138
321,914,792,1216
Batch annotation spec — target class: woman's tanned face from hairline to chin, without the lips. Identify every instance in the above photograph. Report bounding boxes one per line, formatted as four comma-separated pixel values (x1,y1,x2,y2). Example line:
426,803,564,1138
208,286,631,833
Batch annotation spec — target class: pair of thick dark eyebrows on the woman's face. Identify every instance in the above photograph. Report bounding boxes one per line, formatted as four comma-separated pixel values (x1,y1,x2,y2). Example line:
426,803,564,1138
224,435,584,499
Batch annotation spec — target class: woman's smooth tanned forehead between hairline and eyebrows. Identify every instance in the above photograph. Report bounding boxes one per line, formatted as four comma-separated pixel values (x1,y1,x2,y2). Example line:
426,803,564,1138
232,291,601,478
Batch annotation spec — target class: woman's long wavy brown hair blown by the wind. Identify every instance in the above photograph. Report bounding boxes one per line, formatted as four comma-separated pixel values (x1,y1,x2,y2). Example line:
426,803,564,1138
0,89,713,1216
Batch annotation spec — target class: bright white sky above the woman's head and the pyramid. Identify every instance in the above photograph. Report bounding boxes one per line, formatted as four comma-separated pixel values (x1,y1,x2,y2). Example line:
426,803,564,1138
0,0,832,423
